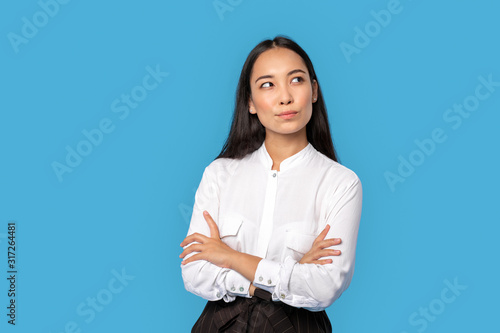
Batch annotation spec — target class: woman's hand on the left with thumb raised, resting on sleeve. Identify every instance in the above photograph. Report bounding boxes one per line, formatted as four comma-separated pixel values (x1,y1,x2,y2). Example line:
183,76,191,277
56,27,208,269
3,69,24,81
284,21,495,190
179,211,237,268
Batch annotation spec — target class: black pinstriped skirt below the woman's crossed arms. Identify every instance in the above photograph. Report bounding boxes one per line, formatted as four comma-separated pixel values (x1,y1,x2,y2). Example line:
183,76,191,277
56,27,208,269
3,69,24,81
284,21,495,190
191,288,332,333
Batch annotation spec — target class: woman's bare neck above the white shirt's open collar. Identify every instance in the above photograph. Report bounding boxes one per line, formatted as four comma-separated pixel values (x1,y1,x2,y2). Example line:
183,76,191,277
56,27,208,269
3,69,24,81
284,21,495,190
264,134,309,171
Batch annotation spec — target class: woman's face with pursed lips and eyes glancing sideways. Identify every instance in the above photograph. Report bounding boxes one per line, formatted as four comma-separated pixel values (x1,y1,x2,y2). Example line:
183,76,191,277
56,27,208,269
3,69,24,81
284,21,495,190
249,47,318,138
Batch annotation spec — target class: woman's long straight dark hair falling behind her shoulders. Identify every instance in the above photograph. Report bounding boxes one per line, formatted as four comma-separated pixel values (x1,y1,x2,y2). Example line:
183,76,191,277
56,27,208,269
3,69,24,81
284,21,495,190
216,36,339,162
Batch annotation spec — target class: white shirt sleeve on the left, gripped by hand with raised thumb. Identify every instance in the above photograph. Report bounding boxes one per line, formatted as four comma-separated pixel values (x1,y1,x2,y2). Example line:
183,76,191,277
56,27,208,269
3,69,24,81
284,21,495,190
181,166,251,302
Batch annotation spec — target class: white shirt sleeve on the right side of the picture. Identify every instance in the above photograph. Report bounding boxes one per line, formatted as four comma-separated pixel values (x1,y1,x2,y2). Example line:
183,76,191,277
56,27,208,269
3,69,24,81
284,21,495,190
253,172,362,311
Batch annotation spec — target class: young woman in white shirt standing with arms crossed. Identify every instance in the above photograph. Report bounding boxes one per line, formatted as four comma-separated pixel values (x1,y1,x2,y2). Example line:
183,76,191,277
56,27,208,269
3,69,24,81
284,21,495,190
180,37,362,333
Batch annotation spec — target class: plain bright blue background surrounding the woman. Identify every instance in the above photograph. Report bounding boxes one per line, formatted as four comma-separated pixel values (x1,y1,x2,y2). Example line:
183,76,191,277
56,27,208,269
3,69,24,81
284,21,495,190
0,0,500,333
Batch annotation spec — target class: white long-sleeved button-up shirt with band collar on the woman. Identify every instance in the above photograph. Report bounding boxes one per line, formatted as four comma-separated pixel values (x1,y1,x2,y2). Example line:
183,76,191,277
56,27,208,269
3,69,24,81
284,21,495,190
181,143,362,311
